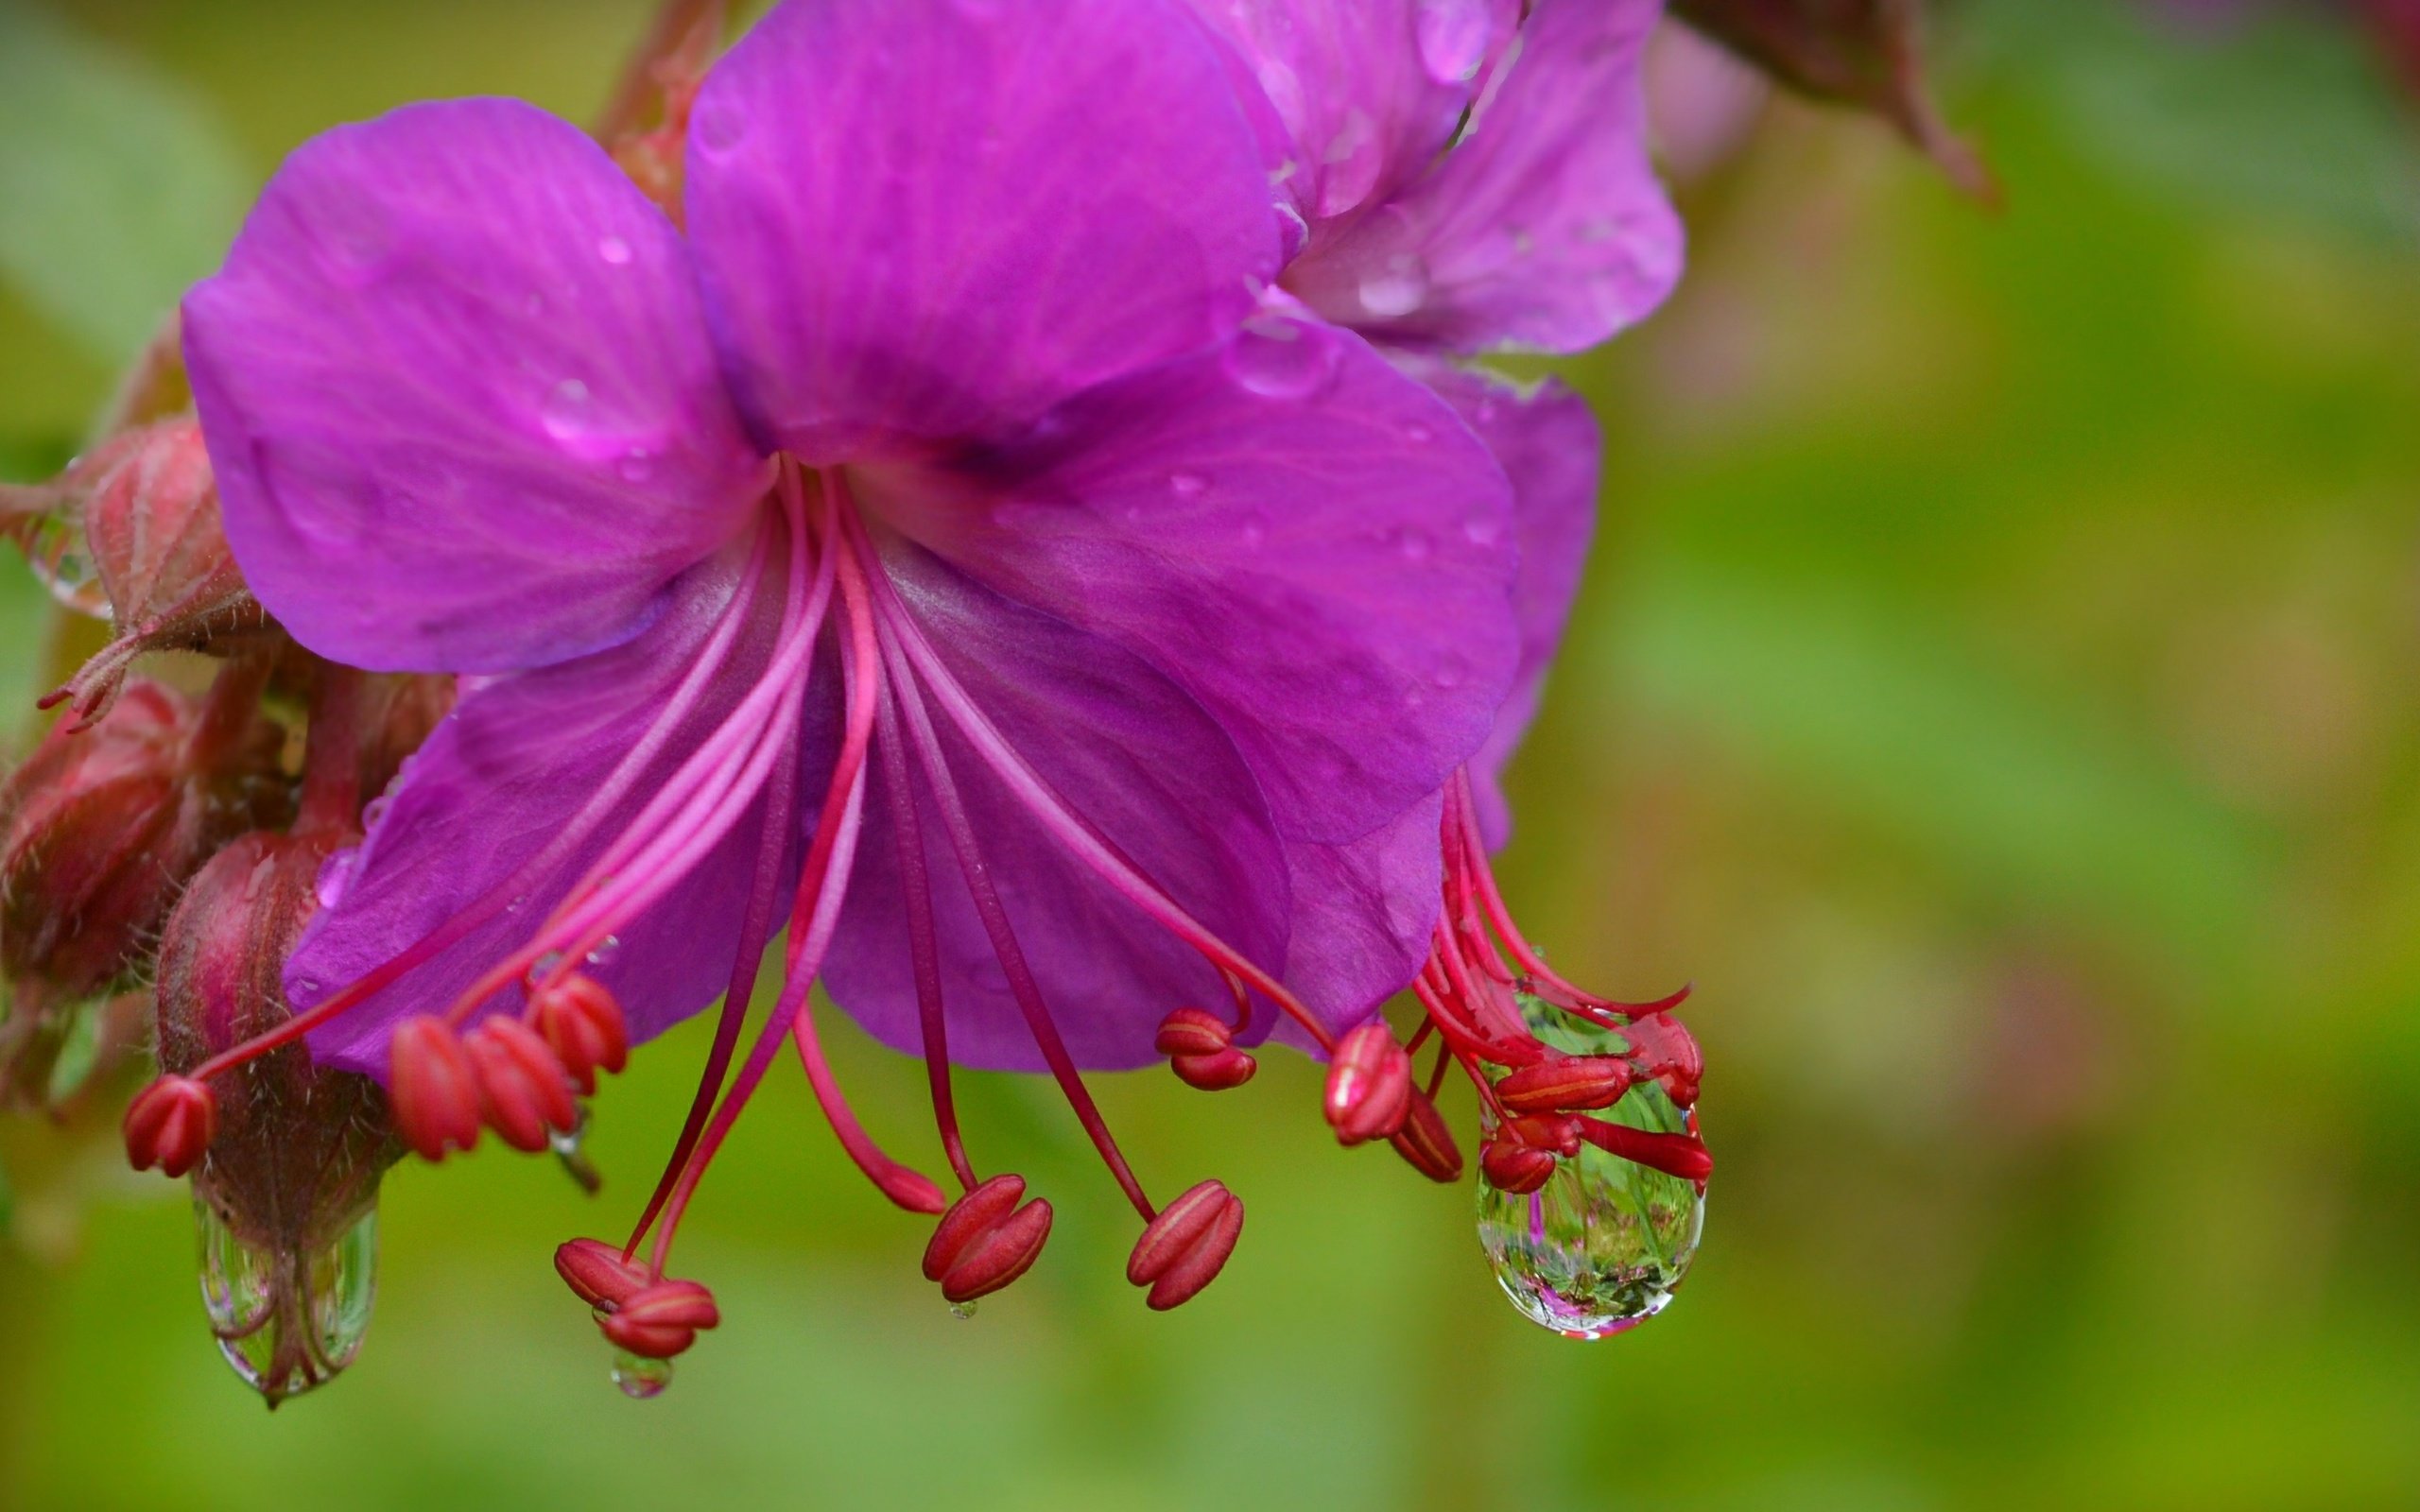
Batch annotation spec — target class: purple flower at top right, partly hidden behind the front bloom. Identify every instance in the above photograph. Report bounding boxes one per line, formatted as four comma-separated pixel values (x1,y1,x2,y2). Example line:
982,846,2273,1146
1196,0,1682,844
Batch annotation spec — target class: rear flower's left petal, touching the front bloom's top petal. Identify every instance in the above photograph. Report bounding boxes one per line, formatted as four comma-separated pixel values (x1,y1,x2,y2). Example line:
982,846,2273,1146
1193,0,1517,234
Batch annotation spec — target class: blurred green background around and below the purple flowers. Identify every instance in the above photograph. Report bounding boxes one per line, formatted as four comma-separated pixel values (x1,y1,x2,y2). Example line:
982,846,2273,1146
0,0,2420,1509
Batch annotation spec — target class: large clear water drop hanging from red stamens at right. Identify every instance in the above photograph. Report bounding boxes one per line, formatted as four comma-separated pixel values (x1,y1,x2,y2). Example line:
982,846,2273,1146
1478,1002,1706,1338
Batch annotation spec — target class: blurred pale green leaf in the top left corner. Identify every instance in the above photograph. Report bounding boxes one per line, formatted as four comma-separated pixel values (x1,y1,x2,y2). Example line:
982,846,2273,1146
0,0,251,363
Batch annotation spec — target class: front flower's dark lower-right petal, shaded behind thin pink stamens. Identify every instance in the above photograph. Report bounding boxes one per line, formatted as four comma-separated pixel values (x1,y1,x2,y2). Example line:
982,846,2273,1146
825,540,1288,1070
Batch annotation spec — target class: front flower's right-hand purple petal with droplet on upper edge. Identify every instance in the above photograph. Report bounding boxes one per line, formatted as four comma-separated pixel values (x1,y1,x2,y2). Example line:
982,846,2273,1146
864,317,1517,844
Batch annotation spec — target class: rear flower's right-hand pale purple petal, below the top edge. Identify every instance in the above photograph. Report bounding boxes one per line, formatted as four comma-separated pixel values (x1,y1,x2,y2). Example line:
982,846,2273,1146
1285,0,1682,351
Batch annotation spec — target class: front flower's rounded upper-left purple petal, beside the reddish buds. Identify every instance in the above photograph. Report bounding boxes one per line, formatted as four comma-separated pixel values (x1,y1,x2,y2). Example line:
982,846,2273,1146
184,99,760,673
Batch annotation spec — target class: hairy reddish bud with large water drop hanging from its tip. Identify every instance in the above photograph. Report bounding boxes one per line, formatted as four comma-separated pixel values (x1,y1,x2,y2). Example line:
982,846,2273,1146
152,833,397,1403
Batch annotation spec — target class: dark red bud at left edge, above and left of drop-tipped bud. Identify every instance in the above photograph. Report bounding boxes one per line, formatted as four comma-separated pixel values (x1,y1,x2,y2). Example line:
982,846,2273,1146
0,682,285,999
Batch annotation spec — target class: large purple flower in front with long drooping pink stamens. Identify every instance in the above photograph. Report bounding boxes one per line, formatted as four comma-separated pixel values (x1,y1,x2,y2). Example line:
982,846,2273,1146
170,0,1529,1355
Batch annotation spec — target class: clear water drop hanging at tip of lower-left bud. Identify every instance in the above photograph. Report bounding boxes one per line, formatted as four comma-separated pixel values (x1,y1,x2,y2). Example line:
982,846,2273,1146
194,1193,377,1403
